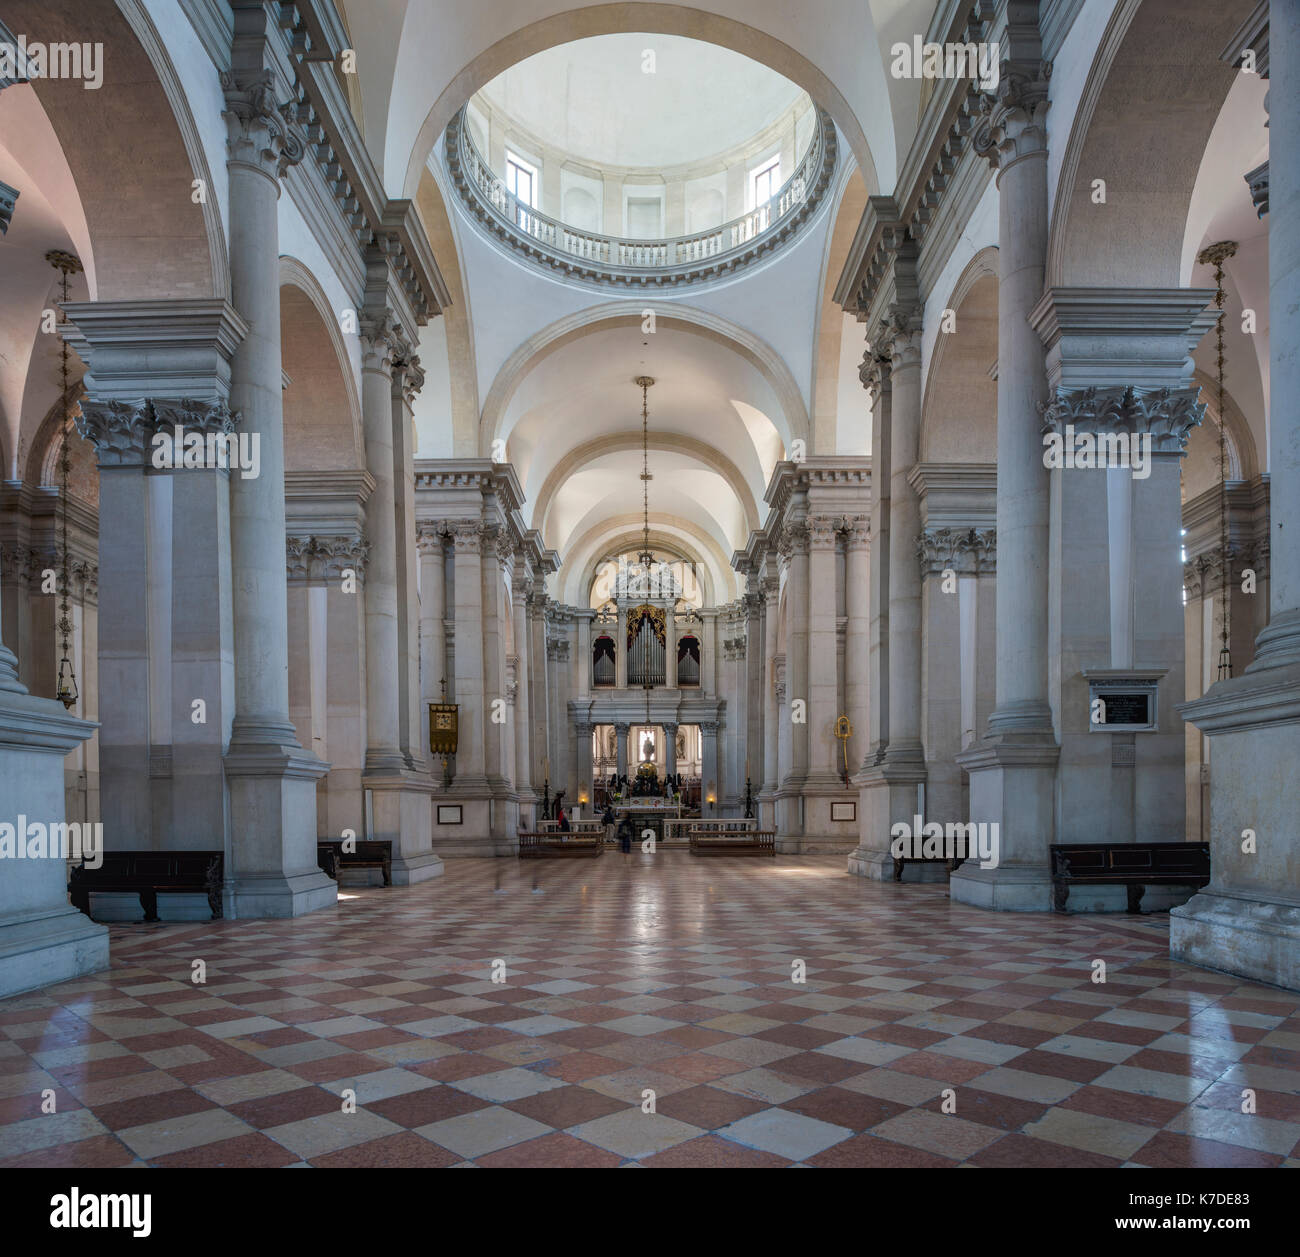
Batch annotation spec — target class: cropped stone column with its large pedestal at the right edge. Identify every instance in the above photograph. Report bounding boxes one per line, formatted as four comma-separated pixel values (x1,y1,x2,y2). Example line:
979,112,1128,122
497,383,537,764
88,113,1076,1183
1170,0,1300,989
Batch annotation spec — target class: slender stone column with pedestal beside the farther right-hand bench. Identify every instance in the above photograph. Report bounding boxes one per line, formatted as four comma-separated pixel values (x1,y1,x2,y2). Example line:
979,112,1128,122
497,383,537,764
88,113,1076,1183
849,308,930,881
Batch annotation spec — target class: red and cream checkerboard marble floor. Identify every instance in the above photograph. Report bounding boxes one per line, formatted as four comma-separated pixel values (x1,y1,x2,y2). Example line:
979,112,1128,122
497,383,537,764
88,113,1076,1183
0,853,1300,1166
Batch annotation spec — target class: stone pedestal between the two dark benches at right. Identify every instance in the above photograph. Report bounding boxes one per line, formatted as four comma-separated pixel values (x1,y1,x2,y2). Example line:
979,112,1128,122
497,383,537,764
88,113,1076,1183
948,729,1061,913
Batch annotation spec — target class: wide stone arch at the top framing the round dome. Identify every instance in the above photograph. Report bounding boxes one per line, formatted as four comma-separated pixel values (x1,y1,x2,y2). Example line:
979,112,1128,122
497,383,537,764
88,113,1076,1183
397,0,893,206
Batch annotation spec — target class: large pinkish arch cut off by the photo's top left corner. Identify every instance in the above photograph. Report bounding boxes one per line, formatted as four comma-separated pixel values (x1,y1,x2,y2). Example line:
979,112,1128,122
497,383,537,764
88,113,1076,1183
5,0,229,300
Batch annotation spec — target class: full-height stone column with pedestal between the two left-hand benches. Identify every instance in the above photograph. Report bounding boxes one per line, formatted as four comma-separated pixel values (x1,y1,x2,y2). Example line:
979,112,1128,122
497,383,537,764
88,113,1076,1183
221,56,337,918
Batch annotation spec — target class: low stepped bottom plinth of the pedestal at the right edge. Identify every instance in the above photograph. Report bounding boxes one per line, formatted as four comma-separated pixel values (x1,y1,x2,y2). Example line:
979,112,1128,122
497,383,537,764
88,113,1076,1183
1169,890,1300,991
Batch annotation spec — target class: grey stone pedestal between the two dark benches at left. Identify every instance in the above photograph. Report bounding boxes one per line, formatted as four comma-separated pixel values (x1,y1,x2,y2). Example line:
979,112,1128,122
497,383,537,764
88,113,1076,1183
222,742,338,920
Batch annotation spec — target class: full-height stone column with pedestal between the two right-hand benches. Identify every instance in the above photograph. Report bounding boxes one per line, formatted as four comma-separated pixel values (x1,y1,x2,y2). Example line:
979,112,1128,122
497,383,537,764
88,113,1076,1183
950,21,1060,910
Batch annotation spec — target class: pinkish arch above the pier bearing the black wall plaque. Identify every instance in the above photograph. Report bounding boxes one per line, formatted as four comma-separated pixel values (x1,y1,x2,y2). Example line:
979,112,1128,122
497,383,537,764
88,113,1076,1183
1047,0,1248,289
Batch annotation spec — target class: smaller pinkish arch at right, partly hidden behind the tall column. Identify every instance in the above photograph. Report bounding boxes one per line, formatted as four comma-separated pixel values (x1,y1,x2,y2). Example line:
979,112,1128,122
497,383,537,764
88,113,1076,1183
918,246,998,463
